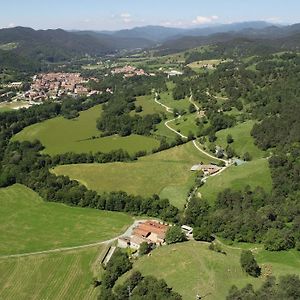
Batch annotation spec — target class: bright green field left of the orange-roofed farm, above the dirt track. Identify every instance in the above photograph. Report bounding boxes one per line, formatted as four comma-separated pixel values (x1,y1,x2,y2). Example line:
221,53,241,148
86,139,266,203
0,185,132,255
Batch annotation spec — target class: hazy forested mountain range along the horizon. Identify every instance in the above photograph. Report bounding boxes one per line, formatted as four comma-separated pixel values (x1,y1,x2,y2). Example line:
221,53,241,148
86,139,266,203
0,21,300,69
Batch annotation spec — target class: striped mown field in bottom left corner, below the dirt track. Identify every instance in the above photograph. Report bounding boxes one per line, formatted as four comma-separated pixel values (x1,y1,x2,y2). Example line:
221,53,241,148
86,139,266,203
0,246,105,300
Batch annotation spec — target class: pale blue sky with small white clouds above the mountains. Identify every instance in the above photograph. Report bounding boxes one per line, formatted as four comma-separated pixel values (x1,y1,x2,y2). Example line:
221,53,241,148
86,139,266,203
0,0,300,30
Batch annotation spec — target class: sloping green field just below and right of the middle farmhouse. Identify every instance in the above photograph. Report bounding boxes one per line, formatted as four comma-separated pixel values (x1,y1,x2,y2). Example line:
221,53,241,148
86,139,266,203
199,158,272,203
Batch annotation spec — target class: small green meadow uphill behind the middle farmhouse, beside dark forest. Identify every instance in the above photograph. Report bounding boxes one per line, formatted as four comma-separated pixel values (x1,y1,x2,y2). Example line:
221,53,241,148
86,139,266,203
216,121,265,159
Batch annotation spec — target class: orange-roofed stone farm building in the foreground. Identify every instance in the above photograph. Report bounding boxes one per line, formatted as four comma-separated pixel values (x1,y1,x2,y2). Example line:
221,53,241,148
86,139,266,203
118,221,169,249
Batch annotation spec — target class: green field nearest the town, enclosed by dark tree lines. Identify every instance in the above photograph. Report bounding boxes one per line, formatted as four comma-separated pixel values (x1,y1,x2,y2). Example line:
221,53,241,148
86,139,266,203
13,105,159,155
